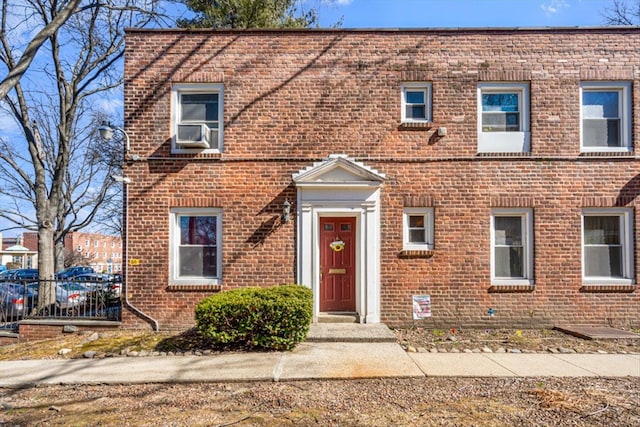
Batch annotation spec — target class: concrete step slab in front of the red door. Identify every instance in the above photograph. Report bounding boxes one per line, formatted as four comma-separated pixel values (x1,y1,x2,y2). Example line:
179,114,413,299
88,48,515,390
307,323,396,343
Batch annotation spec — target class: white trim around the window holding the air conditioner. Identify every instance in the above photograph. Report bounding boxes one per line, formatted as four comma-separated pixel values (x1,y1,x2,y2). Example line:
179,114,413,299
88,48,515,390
171,83,224,154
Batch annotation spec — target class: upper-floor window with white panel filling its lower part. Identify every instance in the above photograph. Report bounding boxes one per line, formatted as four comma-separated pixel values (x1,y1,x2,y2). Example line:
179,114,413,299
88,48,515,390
478,83,530,153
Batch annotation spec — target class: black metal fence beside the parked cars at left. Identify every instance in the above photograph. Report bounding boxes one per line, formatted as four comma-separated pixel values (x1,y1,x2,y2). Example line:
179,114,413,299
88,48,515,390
0,278,122,327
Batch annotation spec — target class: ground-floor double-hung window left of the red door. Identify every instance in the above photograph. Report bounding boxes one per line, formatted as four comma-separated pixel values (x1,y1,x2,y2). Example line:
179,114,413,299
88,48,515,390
170,208,222,284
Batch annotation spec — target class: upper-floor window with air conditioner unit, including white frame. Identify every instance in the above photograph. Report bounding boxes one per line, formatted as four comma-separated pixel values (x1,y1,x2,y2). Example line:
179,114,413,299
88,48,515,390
171,84,224,153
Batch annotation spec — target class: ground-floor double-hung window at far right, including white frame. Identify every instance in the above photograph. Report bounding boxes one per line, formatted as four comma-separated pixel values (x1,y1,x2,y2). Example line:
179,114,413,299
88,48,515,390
582,208,633,284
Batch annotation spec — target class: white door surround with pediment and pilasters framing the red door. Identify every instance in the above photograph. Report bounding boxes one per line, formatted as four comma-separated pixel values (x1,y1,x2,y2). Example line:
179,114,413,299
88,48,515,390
293,154,385,323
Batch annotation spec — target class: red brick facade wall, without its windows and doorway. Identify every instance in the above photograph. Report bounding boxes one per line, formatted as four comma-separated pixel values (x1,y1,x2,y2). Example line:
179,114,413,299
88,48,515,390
124,29,640,328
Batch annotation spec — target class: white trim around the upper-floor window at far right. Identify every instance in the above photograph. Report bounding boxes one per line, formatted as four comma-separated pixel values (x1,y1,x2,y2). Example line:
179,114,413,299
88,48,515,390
579,82,632,152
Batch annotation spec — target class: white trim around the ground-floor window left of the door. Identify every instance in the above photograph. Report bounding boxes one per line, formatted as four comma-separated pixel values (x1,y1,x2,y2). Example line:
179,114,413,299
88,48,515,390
169,208,223,285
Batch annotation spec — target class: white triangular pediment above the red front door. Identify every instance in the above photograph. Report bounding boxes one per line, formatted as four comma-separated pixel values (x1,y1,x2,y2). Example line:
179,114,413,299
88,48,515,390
293,154,385,187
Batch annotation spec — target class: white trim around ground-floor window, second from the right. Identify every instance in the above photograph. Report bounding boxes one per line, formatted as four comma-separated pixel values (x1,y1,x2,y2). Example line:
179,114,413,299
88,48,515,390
490,208,534,285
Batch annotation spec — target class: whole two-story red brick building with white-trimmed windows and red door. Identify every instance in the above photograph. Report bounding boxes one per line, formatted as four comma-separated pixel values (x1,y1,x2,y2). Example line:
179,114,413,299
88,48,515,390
123,28,640,329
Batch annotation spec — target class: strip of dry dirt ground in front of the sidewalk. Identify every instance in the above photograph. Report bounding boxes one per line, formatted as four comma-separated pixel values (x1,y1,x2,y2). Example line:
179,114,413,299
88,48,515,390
0,378,640,426
